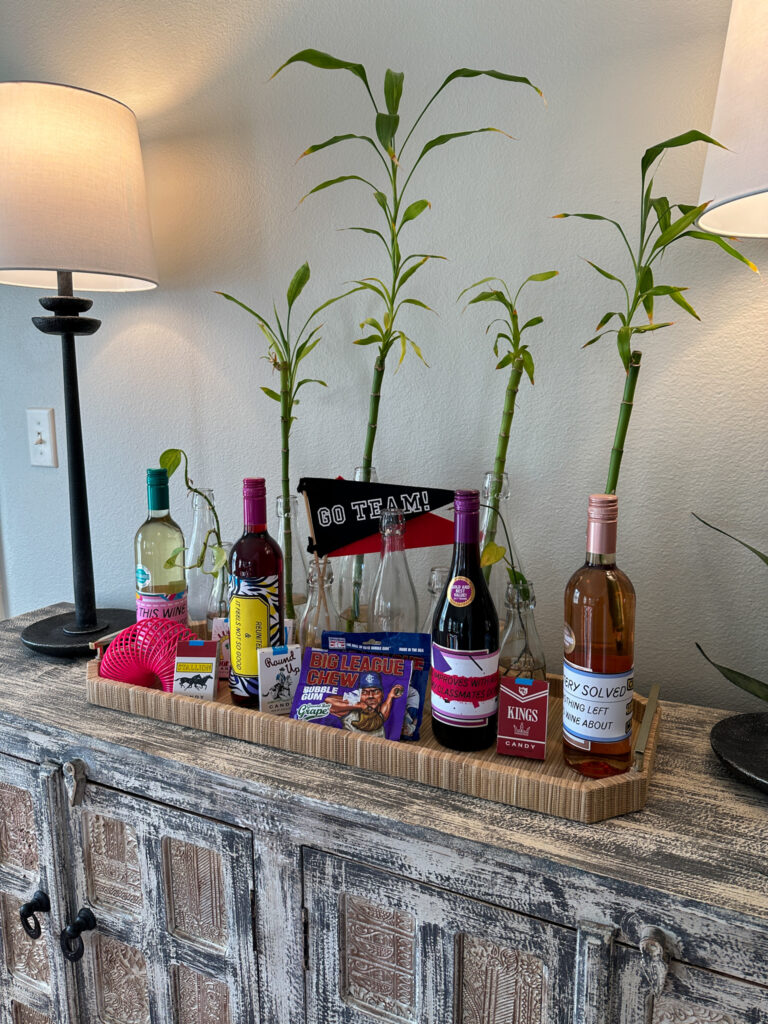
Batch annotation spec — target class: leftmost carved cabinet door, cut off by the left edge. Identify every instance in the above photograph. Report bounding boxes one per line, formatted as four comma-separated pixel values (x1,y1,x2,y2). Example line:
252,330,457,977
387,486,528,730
0,755,76,1024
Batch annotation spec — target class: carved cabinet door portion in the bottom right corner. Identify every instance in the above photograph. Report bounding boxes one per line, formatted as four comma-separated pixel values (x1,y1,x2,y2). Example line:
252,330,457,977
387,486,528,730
613,946,768,1024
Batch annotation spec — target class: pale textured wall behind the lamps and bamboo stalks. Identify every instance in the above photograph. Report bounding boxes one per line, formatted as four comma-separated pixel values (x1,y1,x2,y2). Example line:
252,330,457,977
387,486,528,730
0,0,768,708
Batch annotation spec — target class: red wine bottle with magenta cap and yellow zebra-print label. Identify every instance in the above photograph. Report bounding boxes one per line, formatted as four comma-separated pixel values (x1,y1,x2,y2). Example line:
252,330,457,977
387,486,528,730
229,477,285,708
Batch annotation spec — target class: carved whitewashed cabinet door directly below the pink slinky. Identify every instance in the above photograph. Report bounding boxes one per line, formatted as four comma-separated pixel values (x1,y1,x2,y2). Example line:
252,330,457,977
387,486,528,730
63,783,258,1024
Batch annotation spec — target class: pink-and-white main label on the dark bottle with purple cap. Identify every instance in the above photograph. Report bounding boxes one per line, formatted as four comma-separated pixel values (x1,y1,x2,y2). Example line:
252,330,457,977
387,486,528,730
431,641,499,729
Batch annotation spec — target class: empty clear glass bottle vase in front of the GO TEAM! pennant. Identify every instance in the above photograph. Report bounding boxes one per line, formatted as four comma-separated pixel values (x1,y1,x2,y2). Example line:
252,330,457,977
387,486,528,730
368,512,419,633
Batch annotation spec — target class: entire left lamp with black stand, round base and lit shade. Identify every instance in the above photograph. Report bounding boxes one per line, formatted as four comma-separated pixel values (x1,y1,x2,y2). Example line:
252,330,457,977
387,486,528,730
0,82,157,656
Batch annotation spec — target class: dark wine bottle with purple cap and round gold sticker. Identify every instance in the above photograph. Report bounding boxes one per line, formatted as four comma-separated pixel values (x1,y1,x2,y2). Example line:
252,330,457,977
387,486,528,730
431,490,499,751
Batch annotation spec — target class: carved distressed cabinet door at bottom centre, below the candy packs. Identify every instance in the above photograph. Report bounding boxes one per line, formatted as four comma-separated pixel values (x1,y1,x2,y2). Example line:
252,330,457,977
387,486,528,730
303,849,575,1024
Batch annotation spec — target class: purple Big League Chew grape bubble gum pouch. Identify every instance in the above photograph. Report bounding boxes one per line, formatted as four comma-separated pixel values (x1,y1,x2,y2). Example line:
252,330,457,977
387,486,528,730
291,647,412,739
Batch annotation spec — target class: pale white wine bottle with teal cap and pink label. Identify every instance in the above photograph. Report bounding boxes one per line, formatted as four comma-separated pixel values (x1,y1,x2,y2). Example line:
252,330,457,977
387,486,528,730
133,469,186,625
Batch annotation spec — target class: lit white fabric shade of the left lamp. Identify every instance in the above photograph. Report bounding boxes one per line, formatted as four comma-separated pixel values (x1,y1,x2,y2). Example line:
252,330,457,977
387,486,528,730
0,82,157,292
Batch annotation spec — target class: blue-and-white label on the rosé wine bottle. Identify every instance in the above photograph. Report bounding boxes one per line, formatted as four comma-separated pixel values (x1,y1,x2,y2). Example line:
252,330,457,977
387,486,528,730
562,662,635,751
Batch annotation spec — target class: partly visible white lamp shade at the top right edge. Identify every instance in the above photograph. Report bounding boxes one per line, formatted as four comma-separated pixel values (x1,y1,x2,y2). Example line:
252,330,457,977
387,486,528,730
698,0,768,239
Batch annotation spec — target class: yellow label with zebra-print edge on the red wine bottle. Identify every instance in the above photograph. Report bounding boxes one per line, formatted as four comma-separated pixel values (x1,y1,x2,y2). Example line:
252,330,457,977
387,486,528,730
229,575,283,697
